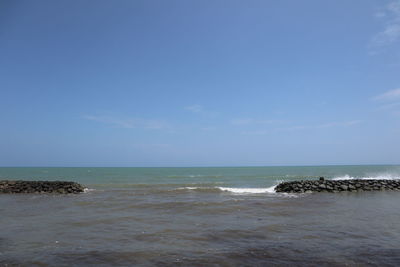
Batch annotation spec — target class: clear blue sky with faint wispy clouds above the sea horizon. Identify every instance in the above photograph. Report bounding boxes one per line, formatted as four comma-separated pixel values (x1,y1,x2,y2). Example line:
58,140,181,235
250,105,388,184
0,0,400,167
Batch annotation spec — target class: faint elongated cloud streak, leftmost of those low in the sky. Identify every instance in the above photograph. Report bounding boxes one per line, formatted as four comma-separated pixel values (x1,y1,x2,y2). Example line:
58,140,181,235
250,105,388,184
83,115,170,129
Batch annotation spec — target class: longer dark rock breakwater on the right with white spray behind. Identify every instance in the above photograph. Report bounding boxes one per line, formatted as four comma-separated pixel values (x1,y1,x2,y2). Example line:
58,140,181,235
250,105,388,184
275,178,400,193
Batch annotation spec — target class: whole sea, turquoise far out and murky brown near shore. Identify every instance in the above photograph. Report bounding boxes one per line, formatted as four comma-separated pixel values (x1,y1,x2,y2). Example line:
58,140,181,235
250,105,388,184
0,166,400,266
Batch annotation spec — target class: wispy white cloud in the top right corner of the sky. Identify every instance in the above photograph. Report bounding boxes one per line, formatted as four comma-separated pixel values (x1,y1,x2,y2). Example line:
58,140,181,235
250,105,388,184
370,0,400,50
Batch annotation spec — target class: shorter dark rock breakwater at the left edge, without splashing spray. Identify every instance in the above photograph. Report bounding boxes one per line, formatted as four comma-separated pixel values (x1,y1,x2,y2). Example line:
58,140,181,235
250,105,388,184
0,181,85,194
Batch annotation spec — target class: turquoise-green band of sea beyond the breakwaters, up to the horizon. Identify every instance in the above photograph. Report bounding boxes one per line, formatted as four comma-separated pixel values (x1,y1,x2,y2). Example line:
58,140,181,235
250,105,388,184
0,165,400,187
